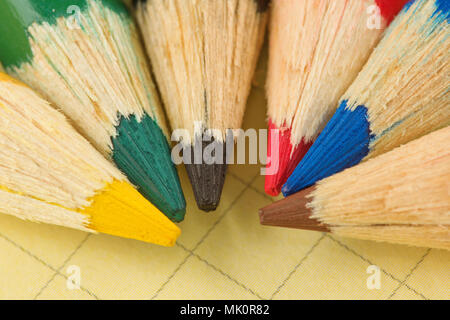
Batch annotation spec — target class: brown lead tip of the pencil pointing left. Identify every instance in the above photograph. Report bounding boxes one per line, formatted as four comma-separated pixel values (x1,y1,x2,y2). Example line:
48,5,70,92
259,187,330,232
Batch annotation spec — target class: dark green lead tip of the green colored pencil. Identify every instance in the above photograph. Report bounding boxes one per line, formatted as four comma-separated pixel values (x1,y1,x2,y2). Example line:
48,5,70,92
112,115,186,222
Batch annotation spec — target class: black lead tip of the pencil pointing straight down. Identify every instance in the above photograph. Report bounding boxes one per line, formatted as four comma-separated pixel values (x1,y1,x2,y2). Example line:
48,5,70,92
183,138,227,212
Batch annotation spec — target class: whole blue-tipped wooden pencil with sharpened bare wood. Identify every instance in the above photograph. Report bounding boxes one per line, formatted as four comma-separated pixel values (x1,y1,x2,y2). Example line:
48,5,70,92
282,0,450,195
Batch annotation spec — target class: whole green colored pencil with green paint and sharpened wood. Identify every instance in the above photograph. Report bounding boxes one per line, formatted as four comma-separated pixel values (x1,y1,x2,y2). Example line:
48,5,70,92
0,0,185,221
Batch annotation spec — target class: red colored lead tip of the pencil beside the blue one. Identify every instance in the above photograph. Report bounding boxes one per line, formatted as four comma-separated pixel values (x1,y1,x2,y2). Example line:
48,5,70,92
264,120,312,197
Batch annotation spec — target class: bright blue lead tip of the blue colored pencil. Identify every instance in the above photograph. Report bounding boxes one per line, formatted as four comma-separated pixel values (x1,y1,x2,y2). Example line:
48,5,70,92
281,101,373,196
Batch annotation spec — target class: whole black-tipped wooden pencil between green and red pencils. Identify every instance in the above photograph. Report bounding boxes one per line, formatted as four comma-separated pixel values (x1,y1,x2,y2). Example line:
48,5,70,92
136,0,268,211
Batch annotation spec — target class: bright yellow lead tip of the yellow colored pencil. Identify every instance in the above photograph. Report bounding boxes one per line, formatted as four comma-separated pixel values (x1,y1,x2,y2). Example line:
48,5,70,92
81,180,181,247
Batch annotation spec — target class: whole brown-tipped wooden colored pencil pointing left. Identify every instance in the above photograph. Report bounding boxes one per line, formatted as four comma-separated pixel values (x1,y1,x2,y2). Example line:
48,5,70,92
260,127,450,250
